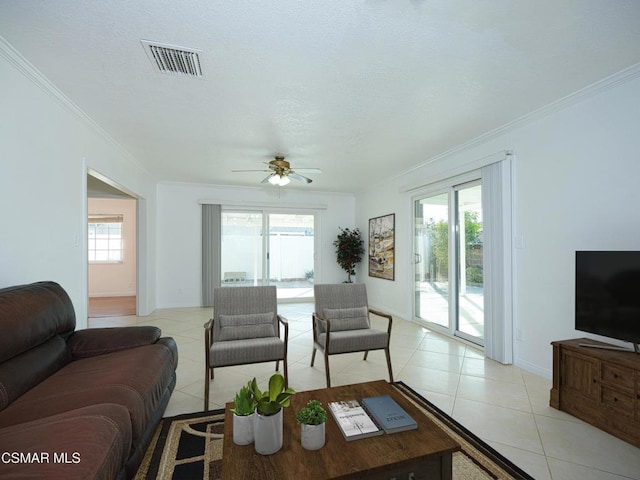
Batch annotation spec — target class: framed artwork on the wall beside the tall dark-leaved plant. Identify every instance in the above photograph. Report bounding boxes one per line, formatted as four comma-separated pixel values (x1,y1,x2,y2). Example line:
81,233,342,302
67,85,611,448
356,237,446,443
369,213,396,280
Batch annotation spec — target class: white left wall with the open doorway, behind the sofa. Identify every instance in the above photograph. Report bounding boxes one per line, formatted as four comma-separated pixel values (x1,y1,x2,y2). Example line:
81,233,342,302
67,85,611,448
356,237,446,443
0,37,155,328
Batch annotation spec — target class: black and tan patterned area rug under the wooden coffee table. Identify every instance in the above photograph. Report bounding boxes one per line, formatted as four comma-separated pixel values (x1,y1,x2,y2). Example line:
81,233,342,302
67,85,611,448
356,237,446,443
135,382,533,480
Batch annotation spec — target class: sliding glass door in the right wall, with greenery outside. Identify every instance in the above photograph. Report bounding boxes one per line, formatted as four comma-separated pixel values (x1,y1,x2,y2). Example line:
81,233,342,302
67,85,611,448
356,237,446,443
414,180,484,345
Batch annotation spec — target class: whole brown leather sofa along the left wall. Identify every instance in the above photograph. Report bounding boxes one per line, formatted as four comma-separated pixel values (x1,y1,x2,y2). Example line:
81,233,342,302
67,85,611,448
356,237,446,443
0,282,178,480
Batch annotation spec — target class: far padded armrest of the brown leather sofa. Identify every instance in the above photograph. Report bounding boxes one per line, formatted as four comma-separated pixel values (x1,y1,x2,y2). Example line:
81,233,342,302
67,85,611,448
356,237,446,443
67,326,162,359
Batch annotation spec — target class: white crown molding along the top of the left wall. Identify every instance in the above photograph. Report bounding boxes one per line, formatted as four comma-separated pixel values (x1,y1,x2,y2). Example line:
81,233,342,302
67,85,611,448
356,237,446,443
0,35,153,178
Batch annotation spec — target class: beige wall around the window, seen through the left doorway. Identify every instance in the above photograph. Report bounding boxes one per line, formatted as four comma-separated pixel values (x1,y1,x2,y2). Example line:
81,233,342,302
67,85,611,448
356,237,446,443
88,198,138,297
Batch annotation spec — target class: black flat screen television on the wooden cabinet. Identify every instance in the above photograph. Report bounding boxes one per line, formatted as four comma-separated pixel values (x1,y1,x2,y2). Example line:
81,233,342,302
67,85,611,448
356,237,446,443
575,251,640,353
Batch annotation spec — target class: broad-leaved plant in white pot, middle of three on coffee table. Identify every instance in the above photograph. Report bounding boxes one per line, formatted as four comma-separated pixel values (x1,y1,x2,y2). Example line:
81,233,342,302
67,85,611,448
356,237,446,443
250,373,296,455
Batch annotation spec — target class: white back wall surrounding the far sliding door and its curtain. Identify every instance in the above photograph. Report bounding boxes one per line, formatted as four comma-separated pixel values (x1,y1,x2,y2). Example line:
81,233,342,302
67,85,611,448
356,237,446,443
157,183,355,307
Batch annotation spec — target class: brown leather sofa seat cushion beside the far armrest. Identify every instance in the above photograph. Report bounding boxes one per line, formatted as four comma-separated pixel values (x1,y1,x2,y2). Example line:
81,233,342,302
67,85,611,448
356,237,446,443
0,339,177,444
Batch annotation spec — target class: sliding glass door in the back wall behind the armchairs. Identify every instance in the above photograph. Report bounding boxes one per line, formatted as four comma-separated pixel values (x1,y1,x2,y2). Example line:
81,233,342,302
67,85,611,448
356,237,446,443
221,210,315,299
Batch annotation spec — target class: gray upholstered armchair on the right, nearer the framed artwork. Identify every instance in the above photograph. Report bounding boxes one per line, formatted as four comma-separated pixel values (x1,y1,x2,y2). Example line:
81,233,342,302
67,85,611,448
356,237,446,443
311,283,393,387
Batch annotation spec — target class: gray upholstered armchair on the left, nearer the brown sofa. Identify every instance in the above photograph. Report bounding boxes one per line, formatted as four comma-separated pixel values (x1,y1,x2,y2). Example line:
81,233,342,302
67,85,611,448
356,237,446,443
204,286,289,410
